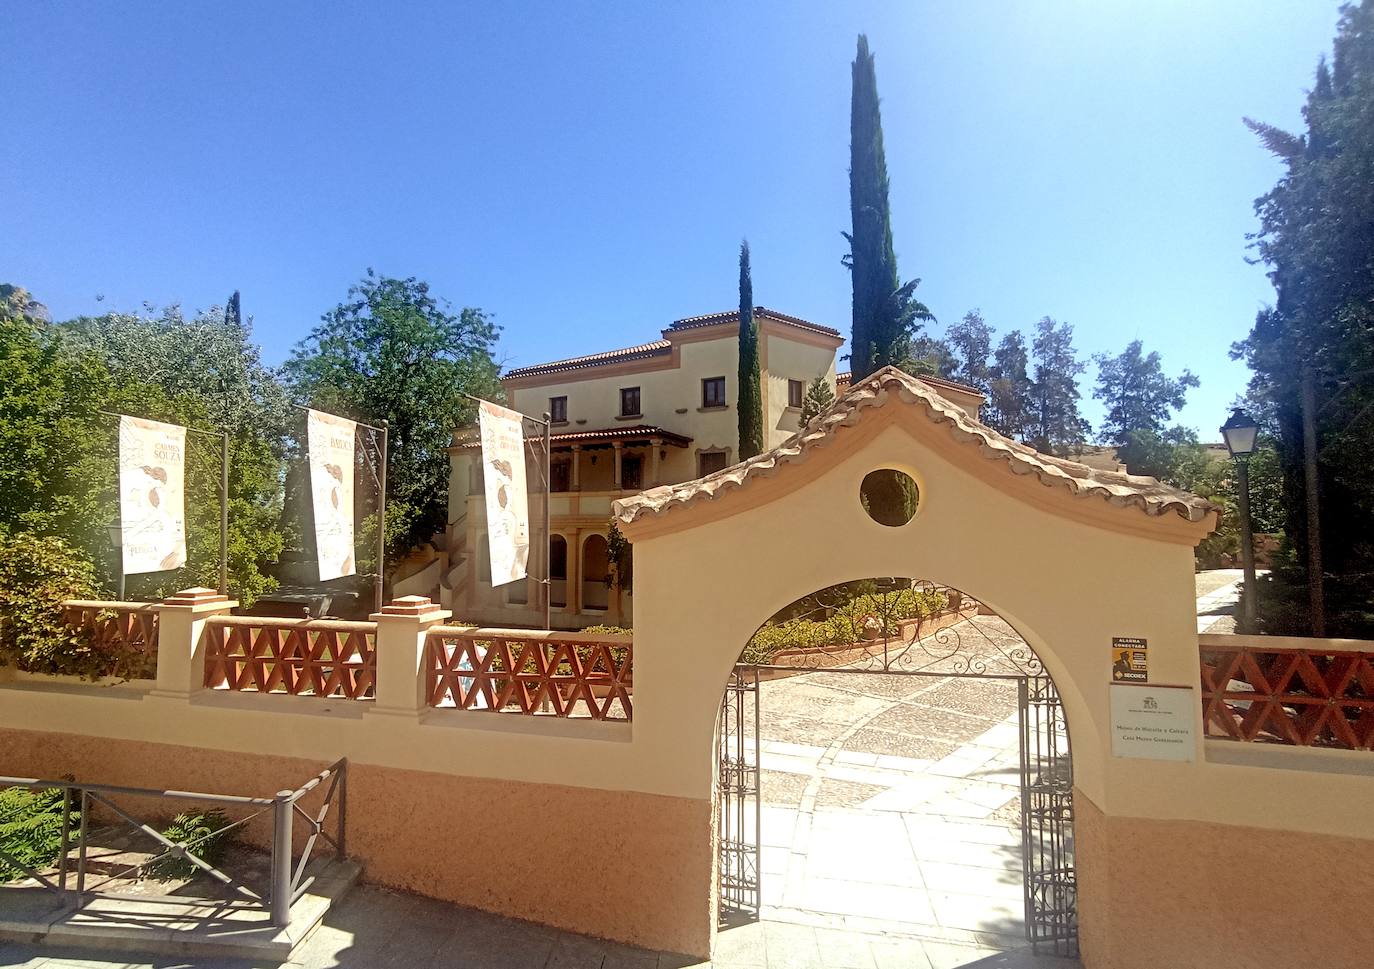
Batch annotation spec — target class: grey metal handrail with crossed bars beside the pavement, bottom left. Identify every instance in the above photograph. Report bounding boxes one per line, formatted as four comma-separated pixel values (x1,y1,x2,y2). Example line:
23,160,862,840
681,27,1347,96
0,757,348,928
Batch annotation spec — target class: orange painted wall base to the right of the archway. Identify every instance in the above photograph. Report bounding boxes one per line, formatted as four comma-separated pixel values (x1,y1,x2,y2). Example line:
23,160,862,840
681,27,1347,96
1073,792,1374,969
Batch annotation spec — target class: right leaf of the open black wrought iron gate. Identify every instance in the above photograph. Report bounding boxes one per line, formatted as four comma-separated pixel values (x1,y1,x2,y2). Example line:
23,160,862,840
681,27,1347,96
1018,676,1079,955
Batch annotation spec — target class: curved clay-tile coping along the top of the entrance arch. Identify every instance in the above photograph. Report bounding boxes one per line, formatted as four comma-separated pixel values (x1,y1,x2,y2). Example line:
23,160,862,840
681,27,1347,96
613,367,1216,524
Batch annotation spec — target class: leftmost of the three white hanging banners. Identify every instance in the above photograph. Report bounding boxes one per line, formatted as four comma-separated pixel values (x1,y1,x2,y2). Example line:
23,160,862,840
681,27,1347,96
120,416,185,576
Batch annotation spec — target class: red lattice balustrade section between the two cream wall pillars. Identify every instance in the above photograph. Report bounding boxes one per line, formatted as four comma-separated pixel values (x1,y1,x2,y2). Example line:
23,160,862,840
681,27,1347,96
205,616,376,700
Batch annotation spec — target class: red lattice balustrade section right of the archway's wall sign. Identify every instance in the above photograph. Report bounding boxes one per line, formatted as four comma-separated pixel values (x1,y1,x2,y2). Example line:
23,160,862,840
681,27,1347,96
1198,634,1374,750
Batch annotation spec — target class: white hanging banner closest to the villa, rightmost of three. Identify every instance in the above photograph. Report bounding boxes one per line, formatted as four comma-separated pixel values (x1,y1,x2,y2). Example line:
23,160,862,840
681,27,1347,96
478,400,529,586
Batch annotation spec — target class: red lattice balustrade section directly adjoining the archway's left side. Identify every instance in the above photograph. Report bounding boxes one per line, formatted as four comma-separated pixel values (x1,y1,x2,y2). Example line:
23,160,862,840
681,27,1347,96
426,625,633,720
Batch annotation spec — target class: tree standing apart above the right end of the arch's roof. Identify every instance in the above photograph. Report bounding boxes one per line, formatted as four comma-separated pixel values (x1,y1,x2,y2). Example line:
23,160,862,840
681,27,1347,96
1092,339,1198,477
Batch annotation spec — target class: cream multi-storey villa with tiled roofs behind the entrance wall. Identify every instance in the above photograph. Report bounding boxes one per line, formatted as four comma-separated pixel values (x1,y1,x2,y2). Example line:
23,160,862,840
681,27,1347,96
434,307,982,628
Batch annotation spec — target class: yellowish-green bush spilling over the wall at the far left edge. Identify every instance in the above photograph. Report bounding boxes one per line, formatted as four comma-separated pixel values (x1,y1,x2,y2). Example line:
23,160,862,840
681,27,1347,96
0,532,102,676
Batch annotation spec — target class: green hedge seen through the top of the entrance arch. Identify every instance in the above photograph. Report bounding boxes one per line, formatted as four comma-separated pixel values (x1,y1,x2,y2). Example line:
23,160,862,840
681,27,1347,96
741,584,949,664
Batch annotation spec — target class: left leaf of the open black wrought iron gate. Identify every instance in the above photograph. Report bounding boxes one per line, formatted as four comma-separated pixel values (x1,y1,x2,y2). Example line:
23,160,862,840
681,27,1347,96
716,665,763,921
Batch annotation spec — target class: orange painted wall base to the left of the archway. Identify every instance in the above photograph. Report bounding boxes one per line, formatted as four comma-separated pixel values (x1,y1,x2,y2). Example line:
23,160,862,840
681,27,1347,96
0,730,712,957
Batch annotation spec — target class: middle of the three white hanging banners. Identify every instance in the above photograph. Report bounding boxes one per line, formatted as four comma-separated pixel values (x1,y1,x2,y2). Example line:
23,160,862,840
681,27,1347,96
305,411,357,581
